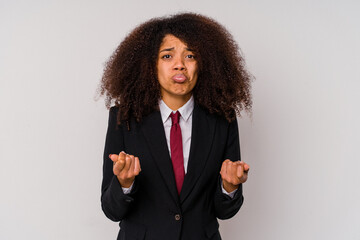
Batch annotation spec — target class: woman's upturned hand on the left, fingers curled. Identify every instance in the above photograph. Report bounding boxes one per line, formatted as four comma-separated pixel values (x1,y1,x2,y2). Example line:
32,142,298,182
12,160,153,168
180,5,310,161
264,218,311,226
109,152,141,188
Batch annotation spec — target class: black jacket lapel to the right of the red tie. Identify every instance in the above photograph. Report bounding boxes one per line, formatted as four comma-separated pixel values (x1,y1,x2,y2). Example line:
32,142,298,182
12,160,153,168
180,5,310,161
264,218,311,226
180,104,216,203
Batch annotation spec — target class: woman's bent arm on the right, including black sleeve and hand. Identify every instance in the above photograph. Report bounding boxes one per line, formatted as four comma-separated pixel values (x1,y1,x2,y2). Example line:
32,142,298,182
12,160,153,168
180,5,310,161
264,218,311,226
214,117,246,219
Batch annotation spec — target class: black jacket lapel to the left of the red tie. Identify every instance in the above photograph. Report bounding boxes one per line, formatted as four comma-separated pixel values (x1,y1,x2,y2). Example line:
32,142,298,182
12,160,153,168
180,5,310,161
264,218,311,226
141,111,179,203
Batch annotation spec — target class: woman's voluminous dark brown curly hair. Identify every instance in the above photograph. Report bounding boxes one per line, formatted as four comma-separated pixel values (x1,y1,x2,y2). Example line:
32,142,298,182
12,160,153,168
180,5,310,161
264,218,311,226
100,13,252,124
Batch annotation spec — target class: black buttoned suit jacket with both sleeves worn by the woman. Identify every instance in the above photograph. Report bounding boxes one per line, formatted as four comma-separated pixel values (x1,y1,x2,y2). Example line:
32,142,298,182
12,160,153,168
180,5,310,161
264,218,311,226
101,104,243,240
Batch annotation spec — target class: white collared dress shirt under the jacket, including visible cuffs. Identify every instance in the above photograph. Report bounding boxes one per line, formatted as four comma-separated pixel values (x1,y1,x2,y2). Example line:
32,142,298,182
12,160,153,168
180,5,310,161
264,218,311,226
122,96,236,198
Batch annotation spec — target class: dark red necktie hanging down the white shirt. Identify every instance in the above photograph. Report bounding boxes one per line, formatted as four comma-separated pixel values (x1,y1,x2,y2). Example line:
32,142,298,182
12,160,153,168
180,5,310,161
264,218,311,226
170,111,185,195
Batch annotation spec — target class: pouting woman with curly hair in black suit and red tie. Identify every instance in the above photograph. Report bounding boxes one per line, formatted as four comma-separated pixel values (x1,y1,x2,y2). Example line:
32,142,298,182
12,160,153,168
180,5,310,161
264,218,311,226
101,13,251,240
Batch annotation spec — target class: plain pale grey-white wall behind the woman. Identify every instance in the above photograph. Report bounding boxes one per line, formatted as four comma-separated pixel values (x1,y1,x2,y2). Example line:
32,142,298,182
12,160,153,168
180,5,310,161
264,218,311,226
0,0,360,240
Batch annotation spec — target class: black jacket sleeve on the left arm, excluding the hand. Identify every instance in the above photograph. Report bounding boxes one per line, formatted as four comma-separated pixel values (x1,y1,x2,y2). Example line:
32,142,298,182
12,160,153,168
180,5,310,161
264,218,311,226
101,107,137,221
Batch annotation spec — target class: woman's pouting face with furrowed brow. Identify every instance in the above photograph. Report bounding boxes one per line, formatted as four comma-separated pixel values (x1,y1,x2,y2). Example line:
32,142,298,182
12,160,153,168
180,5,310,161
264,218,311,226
157,35,198,102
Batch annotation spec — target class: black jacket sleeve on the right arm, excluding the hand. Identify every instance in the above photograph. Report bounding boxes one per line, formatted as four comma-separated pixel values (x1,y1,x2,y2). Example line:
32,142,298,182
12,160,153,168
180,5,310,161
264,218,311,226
214,119,244,219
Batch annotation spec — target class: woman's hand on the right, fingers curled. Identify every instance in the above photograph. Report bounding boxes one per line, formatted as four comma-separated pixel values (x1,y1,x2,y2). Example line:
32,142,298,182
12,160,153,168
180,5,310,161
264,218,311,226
220,159,250,192
